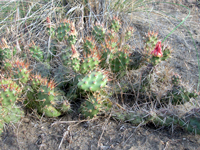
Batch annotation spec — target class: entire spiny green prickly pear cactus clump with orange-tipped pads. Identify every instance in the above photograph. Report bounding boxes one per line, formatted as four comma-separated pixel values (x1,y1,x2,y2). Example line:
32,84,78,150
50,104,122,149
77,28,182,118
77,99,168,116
0,17,200,137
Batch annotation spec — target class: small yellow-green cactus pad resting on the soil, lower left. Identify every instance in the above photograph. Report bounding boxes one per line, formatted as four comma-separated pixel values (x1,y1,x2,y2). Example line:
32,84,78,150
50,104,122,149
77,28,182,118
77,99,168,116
42,105,61,117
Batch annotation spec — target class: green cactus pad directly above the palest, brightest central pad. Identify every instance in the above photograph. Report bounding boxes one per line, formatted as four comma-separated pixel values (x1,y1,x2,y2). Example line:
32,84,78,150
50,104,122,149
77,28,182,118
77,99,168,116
80,58,99,74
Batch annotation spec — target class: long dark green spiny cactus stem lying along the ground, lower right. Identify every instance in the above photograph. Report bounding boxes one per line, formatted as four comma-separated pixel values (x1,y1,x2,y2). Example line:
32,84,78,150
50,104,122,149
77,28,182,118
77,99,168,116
118,110,200,134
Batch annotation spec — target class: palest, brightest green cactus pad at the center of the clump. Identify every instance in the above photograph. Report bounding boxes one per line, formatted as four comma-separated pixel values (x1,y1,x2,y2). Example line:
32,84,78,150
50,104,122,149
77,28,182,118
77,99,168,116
78,72,108,91
